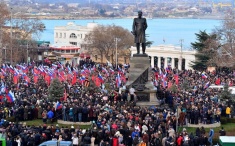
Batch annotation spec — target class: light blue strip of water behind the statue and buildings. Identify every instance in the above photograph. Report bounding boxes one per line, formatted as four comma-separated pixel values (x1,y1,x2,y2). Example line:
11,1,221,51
38,18,222,50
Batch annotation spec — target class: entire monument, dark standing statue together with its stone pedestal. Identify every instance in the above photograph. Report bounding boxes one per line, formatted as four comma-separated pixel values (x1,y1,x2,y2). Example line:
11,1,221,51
126,11,159,106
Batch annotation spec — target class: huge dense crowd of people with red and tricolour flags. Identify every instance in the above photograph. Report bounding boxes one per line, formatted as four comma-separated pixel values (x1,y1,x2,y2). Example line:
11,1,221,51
0,59,235,146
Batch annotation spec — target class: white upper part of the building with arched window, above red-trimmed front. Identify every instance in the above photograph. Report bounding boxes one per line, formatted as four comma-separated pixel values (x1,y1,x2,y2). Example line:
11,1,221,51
54,22,98,47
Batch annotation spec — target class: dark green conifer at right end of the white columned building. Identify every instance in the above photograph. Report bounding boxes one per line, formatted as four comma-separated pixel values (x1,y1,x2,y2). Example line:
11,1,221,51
191,30,219,70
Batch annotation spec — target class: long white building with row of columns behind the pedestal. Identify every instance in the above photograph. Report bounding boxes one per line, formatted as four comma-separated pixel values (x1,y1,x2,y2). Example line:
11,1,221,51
130,45,196,70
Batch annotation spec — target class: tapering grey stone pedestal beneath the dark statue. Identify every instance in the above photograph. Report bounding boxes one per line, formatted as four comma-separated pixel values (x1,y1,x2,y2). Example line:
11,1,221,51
126,54,159,106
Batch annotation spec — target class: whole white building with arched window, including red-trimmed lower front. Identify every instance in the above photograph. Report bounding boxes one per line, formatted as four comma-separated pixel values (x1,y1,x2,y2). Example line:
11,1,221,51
50,22,98,64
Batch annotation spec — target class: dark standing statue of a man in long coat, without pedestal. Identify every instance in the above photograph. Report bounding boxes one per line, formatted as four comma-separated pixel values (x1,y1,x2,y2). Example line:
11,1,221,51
132,11,148,54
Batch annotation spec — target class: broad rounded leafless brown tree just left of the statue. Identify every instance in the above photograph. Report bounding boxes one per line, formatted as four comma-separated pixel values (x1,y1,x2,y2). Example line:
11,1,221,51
85,25,134,62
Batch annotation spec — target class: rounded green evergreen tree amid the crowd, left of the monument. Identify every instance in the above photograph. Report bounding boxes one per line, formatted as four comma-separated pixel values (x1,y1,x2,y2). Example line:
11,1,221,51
49,78,64,101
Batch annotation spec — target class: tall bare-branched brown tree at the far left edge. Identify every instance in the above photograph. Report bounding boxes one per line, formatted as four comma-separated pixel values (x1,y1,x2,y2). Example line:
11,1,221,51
0,3,45,63
